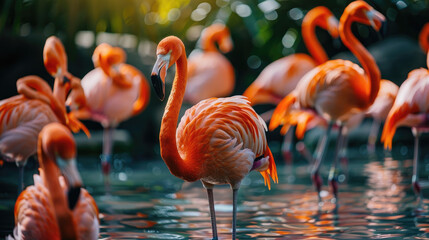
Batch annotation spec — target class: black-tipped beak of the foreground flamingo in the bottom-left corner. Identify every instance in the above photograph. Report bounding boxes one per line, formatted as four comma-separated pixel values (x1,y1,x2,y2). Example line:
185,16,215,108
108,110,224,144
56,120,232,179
57,157,82,210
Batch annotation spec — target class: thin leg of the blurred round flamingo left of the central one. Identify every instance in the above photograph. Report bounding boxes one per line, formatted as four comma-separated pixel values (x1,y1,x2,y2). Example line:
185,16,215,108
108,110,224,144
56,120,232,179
100,127,114,192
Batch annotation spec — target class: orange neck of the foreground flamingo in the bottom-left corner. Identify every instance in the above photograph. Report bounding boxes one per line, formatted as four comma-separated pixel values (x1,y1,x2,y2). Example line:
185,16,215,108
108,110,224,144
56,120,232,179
39,153,77,240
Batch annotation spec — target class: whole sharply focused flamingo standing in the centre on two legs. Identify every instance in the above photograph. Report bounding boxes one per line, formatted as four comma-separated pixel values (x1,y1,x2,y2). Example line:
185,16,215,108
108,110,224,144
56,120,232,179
151,36,278,239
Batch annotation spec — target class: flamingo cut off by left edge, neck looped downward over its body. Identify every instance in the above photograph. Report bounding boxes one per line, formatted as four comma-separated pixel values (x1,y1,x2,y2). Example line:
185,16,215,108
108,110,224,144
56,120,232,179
0,76,67,192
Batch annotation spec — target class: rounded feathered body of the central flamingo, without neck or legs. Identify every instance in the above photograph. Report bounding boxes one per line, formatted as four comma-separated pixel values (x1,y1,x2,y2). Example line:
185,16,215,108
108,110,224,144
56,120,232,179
176,96,267,186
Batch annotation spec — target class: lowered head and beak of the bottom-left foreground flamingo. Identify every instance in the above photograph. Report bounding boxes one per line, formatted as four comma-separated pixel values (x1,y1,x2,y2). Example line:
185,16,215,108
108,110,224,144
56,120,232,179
38,123,82,209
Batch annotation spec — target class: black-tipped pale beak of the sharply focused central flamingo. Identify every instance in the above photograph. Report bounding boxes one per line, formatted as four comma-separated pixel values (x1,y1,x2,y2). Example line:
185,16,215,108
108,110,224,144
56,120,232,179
150,53,170,101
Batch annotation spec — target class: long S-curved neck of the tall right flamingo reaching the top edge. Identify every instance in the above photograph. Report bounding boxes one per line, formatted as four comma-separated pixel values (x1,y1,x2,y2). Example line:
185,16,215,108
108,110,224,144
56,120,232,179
339,18,381,105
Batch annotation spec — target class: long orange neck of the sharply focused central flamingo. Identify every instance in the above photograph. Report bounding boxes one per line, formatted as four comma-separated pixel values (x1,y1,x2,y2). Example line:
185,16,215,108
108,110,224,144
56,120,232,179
159,48,198,181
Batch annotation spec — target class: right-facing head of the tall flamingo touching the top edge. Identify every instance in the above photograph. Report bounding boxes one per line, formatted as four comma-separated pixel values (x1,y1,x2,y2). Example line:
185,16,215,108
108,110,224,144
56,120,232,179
340,0,385,31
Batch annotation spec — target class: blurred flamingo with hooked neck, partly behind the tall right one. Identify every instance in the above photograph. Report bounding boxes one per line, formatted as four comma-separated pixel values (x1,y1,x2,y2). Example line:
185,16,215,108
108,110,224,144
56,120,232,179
243,6,339,161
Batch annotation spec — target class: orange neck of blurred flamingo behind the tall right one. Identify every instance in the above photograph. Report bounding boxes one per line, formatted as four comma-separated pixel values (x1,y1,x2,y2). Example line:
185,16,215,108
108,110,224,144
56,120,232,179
301,14,328,65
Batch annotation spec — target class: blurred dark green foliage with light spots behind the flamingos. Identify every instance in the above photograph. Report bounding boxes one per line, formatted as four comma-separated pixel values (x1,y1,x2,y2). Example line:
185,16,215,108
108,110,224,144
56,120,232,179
0,0,429,159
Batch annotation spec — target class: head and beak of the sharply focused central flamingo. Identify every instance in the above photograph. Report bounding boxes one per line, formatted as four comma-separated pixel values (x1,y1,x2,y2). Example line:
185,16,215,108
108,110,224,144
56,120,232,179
150,36,186,100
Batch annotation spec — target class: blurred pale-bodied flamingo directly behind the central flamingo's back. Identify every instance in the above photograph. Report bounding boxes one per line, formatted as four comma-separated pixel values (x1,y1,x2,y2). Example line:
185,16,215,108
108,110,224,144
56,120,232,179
184,23,235,105
